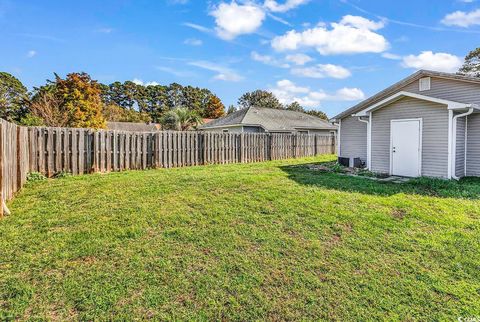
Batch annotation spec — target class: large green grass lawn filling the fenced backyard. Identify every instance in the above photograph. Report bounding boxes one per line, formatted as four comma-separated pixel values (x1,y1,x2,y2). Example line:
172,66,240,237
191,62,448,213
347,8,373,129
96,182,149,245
0,156,480,321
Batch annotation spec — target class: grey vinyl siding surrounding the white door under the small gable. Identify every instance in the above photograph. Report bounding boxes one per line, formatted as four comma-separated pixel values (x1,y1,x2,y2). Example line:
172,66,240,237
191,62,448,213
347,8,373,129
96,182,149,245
372,97,448,177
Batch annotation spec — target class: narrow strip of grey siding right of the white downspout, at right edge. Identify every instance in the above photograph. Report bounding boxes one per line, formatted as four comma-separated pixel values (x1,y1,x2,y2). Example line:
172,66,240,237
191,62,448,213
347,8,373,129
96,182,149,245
467,114,480,176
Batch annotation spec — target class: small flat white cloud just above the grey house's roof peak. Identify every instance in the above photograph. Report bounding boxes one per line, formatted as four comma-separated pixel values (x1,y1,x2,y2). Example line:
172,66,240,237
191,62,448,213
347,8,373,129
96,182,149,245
402,51,463,73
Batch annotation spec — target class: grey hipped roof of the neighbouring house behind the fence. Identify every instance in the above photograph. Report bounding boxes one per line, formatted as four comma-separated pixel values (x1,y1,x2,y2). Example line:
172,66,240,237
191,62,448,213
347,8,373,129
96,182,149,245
200,107,337,132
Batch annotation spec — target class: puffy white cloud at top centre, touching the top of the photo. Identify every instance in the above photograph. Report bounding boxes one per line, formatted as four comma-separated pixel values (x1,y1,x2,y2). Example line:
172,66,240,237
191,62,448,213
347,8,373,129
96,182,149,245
210,1,265,40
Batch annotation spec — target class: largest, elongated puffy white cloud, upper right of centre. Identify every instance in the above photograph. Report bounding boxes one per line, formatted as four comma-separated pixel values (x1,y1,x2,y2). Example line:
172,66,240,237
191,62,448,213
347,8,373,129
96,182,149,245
271,16,389,55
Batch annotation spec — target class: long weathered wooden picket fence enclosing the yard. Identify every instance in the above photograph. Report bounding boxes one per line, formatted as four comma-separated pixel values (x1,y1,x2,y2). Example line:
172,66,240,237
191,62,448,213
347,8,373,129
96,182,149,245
0,120,336,215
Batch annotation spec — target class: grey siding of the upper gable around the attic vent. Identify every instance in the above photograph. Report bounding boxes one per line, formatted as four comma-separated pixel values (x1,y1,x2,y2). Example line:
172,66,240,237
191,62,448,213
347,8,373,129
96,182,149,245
400,77,480,104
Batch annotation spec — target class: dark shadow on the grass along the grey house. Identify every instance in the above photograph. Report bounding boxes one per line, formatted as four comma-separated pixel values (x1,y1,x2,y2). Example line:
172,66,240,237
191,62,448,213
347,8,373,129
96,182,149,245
280,162,480,199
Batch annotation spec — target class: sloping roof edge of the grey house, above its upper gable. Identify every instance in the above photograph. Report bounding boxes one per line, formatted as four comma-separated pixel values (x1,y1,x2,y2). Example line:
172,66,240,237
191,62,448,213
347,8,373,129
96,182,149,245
331,70,480,120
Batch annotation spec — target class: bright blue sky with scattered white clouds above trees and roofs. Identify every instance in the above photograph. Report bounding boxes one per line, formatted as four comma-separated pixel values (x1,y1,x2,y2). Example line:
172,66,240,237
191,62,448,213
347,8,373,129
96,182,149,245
0,0,480,116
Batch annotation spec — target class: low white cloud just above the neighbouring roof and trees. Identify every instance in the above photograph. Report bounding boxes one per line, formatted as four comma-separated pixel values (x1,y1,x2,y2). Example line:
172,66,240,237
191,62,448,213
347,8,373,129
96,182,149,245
270,79,365,108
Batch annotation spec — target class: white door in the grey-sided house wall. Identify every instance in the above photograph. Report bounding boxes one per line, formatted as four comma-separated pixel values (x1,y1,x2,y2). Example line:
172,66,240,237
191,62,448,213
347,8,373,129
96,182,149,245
390,120,422,177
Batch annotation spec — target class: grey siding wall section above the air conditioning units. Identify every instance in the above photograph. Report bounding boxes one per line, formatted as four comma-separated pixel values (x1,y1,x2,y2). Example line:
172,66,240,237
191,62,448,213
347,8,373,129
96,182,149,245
340,116,367,162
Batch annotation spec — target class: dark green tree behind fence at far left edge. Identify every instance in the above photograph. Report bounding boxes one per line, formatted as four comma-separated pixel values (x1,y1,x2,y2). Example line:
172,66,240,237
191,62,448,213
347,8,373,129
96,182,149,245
0,72,28,122
